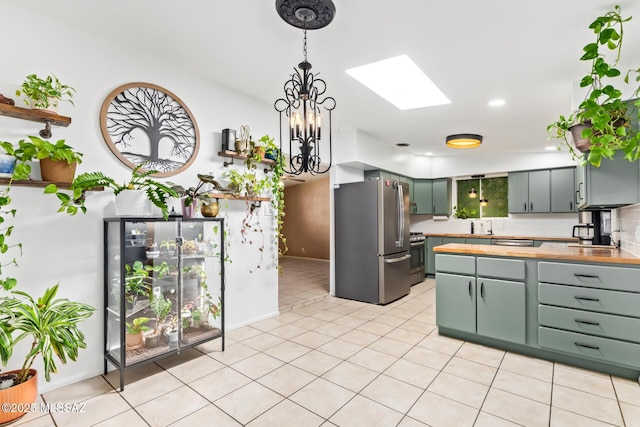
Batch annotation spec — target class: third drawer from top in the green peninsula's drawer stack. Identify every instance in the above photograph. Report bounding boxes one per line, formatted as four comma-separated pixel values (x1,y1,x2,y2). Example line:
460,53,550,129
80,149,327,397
538,305,640,343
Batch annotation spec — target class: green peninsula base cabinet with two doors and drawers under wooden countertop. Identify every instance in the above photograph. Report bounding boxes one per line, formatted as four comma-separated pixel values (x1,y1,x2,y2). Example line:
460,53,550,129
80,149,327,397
435,250,640,380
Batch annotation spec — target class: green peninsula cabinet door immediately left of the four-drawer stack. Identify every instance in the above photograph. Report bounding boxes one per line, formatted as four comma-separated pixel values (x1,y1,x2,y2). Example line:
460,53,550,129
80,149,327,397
476,277,526,344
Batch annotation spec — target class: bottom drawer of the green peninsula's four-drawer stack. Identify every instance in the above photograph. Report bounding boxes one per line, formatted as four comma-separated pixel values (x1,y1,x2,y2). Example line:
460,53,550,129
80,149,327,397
538,326,640,369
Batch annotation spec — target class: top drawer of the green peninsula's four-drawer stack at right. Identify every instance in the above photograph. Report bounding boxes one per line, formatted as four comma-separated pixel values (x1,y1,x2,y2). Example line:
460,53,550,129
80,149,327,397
538,261,640,292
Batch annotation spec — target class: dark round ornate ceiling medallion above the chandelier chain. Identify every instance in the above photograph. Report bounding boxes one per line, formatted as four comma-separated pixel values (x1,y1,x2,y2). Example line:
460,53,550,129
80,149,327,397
276,0,336,30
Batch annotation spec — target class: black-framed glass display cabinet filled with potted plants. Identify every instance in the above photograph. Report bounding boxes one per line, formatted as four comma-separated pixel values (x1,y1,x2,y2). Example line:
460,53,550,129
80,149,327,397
104,216,225,390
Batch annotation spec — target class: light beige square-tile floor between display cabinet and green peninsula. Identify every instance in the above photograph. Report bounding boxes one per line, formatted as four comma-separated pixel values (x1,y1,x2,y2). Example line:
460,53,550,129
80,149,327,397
13,279,640,427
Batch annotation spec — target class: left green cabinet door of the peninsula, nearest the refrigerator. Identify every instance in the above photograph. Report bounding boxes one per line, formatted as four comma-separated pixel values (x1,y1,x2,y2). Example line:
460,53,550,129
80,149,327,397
436,273,476,333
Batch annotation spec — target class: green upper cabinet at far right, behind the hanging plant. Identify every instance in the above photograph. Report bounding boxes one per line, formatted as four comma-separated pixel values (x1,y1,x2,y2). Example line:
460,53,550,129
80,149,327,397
576,153,640,210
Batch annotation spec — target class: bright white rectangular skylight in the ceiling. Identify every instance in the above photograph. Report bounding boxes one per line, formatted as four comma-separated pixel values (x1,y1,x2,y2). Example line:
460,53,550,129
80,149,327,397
346,55,451,110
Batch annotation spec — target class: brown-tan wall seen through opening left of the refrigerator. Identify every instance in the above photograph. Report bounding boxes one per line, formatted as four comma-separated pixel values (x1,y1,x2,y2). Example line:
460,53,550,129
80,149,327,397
282,177,330,260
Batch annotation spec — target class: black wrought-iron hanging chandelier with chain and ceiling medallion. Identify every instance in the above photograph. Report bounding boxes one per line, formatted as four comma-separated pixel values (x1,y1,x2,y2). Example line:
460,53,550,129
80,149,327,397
274,0,336,175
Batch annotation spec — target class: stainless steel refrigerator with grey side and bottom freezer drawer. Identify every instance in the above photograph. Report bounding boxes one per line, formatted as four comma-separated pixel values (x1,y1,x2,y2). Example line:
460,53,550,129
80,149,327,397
333,179,411,304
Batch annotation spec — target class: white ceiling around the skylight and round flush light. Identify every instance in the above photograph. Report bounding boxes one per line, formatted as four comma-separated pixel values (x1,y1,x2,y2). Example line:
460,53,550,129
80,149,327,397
9,0,640,160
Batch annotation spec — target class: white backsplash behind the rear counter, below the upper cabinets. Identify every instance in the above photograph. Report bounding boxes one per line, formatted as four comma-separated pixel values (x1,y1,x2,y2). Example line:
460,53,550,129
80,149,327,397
411,213,578,241
